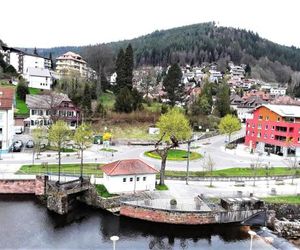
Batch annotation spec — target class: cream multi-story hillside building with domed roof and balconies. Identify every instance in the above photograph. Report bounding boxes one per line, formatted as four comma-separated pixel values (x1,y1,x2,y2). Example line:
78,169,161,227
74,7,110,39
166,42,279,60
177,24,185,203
56,51,88,78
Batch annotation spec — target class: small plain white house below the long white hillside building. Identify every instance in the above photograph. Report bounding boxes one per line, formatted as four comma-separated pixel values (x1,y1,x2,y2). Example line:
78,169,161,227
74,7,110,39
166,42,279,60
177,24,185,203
24,67,52,90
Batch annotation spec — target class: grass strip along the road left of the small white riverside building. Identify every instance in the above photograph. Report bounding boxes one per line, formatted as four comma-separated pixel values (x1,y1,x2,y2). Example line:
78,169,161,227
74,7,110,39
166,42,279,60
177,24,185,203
17,163,103,177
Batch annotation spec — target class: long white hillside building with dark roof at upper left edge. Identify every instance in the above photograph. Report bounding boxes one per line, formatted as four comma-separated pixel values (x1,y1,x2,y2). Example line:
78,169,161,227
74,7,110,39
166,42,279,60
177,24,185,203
2,46,51,73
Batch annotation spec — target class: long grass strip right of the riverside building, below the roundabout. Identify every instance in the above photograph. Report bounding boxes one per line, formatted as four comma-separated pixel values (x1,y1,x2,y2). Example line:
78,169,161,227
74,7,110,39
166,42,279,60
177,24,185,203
166,167,298,177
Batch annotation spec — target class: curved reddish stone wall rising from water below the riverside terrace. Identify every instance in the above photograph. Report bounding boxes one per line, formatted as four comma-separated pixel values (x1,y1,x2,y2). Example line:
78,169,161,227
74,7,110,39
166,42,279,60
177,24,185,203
120,204,217,225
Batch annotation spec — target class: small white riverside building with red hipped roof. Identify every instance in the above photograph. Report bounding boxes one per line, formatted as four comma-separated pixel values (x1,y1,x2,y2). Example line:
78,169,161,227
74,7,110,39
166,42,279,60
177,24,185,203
102,159,158,193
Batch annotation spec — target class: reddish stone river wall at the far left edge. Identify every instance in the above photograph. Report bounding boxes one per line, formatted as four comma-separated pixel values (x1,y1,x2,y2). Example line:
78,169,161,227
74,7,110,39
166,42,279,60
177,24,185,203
0,176,45,195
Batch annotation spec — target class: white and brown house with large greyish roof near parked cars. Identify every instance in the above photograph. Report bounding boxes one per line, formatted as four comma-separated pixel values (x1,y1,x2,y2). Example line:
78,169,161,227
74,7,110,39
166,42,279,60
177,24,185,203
24,93,80,129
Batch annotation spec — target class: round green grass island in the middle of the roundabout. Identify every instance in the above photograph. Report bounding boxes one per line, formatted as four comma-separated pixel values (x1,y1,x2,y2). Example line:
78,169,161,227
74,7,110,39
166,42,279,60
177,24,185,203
144,149,202,161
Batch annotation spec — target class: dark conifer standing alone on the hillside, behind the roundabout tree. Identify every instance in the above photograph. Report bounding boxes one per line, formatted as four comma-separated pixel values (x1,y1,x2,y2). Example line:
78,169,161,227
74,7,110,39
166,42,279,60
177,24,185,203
163,63,184,106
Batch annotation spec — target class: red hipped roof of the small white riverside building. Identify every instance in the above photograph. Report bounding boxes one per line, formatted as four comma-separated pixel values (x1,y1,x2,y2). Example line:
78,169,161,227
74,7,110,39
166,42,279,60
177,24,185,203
101,159,158,176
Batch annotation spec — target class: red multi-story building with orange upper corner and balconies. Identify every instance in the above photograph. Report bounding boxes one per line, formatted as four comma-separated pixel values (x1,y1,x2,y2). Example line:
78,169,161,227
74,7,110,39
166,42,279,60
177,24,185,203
245,104,300,157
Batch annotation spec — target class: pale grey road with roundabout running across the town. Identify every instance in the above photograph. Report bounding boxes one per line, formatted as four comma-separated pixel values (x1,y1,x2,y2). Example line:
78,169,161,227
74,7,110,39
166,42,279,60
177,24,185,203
0,130,286,171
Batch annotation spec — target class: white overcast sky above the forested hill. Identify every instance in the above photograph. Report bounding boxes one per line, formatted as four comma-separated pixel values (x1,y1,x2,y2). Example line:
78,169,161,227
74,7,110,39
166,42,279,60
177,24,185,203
0,0,300,48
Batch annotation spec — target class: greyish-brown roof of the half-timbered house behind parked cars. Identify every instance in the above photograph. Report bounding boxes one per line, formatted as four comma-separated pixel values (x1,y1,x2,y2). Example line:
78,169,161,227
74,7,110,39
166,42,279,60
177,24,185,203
26,93,71,109
